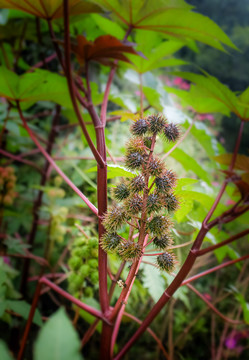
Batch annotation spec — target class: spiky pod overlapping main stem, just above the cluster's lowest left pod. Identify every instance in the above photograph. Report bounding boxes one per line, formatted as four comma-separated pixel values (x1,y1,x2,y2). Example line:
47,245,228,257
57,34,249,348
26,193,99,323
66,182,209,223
103,206,128,232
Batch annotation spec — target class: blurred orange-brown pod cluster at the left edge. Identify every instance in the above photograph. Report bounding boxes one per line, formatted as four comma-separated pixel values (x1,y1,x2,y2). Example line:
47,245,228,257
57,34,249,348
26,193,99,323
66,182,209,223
0,166,16,206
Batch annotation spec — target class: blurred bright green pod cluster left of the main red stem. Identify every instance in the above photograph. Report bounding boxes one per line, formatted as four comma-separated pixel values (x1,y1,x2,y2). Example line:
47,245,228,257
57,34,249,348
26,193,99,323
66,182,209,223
68,237,99,299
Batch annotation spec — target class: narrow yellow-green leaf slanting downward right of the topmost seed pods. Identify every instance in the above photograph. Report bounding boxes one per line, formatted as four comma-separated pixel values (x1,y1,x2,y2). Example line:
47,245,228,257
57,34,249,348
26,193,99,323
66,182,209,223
170,148,210,184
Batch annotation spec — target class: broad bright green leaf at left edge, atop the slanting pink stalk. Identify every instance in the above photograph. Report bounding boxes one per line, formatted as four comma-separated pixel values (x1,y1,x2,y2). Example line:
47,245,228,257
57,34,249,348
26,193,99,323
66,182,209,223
0,66,72,107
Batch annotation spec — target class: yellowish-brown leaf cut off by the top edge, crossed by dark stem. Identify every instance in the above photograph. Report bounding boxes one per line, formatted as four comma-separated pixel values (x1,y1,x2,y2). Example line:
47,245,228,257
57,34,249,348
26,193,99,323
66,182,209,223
0,0,101,20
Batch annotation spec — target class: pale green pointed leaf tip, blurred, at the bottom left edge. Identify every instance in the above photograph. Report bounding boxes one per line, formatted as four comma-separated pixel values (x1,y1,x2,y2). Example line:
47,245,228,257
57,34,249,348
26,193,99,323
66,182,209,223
34,308,82,360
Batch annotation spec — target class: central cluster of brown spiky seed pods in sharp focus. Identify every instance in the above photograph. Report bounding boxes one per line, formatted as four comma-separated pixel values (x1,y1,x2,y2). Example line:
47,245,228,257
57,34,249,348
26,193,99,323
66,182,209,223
101,115,180,271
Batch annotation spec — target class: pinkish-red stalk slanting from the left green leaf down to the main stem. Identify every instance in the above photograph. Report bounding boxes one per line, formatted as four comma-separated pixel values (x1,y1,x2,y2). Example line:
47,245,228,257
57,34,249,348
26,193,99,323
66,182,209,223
17,102,98,215
